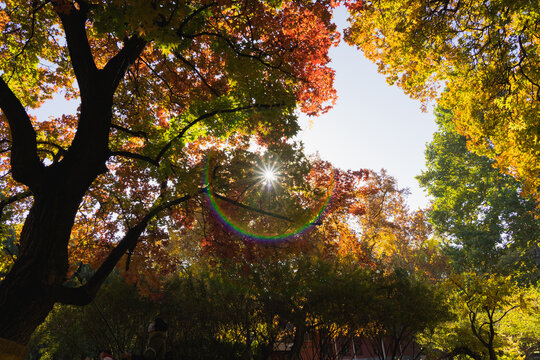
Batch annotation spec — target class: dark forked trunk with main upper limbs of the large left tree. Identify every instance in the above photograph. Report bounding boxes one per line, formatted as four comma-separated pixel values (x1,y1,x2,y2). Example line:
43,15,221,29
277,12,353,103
0,2,146,348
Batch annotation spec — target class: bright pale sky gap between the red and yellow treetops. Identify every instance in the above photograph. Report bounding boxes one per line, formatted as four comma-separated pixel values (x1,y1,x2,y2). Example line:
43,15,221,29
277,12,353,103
299,9,437,209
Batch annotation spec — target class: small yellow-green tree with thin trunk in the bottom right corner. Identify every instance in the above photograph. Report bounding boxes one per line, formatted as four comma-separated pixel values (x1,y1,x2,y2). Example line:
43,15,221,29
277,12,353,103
424,273,534,360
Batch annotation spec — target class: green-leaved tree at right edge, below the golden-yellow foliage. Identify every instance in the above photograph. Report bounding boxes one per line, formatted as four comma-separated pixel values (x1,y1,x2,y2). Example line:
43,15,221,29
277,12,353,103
418,108,540,282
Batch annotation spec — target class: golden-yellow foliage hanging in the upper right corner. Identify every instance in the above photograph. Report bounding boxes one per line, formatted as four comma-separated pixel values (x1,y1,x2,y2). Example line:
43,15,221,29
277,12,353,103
346,0,540,196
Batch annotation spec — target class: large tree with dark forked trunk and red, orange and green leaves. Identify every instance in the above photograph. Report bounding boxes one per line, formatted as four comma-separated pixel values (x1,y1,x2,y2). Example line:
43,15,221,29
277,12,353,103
0,0,346,348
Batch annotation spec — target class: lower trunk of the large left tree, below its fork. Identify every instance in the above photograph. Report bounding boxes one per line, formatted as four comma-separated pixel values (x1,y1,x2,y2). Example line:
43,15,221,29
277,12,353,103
0,182,88,344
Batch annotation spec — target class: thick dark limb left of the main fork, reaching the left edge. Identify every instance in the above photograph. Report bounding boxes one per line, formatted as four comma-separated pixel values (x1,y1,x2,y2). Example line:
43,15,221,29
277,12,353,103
0,76,44,189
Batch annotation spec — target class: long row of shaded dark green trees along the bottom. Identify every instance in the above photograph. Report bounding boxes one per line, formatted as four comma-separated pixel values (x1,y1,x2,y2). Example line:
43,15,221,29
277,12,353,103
30,243,445,360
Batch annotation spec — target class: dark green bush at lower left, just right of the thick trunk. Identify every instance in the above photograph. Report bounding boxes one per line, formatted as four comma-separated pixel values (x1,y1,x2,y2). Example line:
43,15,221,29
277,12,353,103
27,272,154,360
